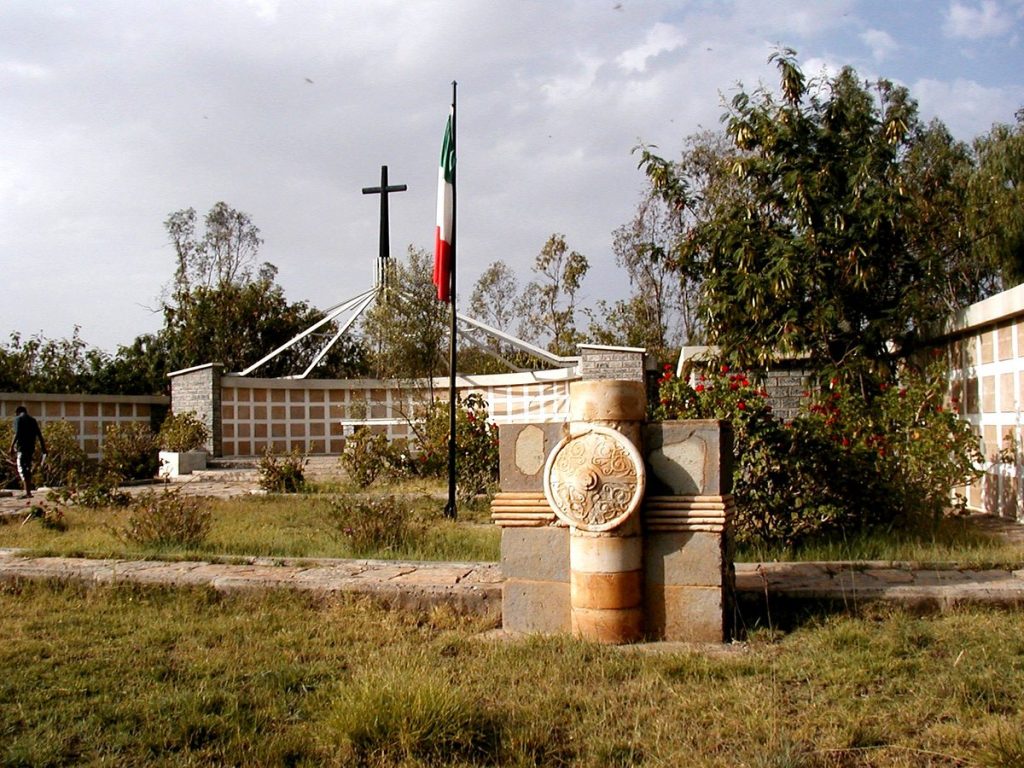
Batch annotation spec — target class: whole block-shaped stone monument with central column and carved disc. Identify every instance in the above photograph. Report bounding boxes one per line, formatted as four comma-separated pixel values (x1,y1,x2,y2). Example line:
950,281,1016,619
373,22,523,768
492,347,734,643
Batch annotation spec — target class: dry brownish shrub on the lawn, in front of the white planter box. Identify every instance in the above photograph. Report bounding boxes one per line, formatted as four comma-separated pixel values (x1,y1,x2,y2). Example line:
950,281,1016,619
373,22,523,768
120,488,210,547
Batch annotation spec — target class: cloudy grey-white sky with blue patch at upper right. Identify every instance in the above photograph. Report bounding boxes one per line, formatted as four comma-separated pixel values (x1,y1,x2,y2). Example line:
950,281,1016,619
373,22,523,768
0,0,1024,351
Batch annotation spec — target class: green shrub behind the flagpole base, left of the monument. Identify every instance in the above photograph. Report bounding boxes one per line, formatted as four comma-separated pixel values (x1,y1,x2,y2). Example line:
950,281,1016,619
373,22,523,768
418,392,498,502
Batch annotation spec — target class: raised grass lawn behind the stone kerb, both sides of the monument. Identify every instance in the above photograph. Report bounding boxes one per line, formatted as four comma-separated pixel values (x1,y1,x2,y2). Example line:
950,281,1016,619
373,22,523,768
0,480,1024,567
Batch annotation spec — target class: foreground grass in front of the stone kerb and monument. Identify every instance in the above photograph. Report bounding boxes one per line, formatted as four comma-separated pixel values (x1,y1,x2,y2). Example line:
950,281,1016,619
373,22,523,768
0,583,1024,768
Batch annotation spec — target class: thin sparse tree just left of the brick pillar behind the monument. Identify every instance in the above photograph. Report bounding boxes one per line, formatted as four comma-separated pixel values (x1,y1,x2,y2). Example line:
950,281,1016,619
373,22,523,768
519,233,590,354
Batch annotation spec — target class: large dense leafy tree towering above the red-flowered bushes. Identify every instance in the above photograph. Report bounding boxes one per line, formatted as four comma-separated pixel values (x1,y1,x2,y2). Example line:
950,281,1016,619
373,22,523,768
641,50,999,385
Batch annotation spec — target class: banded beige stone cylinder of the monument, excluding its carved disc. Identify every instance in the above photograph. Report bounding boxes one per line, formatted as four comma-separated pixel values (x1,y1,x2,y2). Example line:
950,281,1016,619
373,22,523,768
569,380,647,644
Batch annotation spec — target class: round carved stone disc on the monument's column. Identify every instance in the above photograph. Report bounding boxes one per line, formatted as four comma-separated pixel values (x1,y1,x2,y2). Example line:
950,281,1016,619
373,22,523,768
544,426,646,532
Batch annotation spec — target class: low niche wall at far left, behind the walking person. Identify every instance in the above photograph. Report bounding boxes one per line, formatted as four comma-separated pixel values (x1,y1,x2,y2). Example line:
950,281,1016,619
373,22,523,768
0,392,170,459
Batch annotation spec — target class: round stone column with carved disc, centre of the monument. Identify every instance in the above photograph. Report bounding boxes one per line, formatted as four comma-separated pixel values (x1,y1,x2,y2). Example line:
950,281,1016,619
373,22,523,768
544,380,647,643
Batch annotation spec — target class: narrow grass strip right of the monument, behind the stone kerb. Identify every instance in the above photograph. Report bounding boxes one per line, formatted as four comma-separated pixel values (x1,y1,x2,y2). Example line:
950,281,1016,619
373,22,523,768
736,517,1024,568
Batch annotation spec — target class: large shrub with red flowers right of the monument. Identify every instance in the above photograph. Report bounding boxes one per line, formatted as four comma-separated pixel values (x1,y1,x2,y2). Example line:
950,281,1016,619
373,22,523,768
654,364,980,547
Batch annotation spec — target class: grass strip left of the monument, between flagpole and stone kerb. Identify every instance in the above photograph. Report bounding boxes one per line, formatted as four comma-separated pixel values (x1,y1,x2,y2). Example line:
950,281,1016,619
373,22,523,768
0,489,501,561
